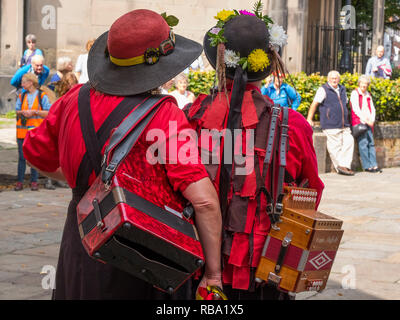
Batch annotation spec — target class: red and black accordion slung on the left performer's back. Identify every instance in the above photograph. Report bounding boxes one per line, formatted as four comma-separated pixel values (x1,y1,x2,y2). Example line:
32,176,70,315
77,171,204,294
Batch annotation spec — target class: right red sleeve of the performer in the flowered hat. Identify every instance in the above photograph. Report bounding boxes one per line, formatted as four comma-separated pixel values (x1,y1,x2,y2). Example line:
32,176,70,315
286,110,324,208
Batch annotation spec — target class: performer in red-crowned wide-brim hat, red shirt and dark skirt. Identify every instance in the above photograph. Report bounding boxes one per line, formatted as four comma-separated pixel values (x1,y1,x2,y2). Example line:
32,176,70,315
23,9,221,300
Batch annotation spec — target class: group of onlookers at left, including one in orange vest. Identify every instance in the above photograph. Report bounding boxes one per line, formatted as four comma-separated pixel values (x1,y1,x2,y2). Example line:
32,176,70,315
10,34,94,191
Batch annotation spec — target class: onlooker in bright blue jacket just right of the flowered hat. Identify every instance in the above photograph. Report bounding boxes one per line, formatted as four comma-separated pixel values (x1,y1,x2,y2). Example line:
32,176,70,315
261,75,301,110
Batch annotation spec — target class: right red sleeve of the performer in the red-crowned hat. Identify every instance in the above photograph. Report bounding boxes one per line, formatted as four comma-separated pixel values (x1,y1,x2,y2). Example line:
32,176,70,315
146,102,208,192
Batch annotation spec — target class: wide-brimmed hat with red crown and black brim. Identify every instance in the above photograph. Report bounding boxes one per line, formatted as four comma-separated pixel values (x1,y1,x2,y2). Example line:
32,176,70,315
87,10,203,96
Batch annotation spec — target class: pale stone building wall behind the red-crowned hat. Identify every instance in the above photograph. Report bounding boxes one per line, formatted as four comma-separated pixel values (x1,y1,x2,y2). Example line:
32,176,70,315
0,0,254,72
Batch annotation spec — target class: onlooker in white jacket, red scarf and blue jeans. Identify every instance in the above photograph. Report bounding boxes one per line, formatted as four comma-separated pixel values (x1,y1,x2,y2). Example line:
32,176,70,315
350,75,382,172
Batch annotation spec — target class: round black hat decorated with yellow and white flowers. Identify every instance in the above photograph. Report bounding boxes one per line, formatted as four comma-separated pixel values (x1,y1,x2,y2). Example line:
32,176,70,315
203,15,272,82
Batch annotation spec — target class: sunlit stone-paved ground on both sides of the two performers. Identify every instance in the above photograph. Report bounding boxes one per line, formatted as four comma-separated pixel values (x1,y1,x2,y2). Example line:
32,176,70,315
0,118,400,300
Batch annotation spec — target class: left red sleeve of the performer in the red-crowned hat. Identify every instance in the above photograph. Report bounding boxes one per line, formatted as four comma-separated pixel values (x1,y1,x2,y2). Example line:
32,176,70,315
23,94,63,172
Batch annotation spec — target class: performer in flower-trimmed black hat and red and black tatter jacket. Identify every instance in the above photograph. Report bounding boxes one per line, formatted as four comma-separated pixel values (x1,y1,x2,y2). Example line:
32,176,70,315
184,9,324,300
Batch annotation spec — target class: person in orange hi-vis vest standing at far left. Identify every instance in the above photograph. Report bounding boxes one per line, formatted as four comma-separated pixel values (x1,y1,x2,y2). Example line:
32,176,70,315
14,73,51,191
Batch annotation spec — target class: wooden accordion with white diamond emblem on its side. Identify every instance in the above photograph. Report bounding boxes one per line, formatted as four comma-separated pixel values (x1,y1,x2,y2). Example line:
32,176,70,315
256,187,343,293
